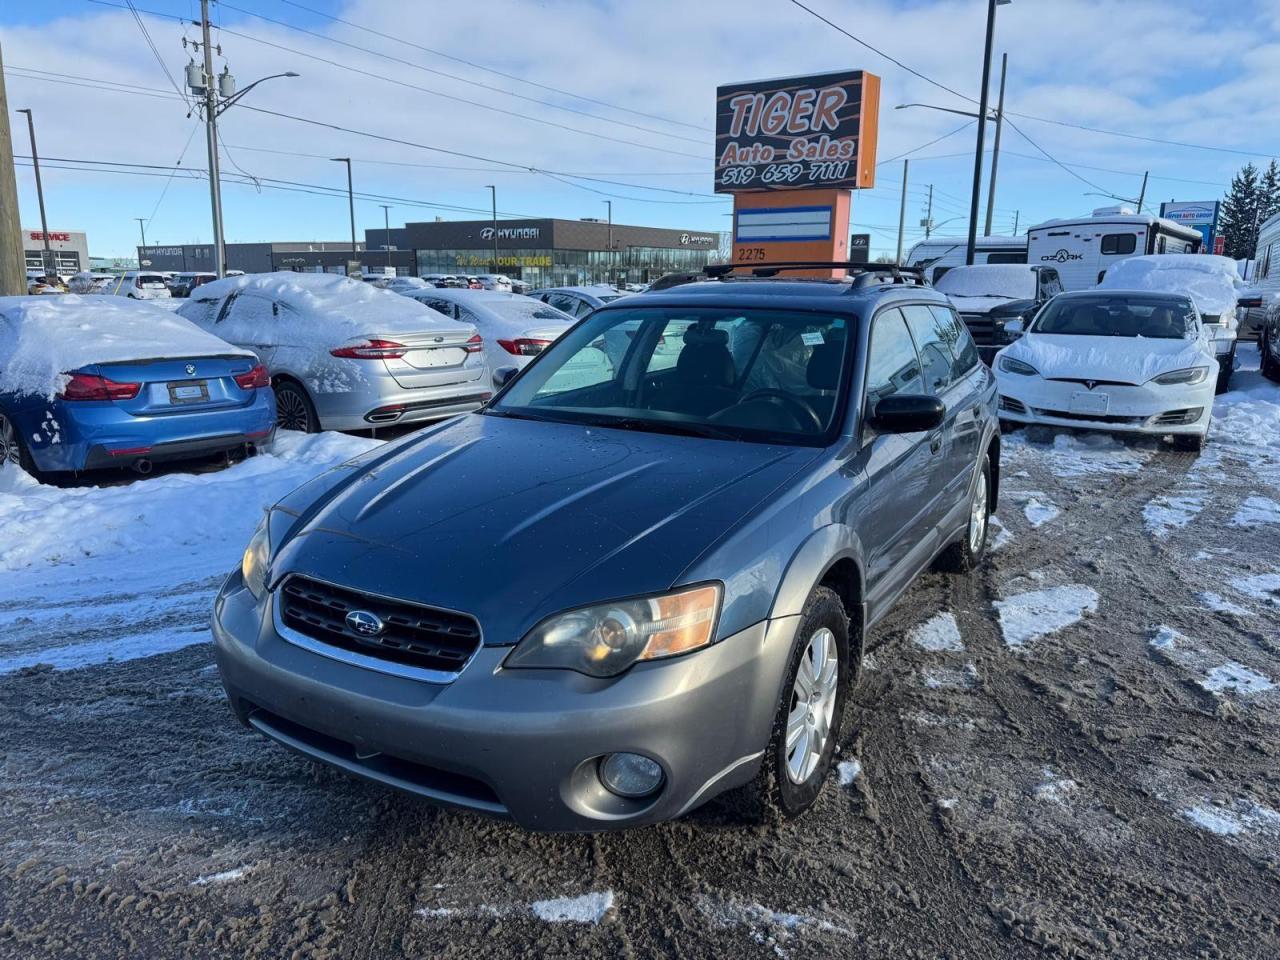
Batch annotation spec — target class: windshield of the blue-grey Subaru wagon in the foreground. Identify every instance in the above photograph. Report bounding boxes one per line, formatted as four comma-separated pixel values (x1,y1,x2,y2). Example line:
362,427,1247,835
486,307,847,445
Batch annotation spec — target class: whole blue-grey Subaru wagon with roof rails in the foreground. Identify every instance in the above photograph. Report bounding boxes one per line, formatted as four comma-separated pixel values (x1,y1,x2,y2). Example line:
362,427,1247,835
214,268,1000,831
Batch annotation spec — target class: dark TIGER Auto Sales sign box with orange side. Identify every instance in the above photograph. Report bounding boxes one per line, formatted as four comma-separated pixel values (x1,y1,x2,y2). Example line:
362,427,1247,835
716,70,879,193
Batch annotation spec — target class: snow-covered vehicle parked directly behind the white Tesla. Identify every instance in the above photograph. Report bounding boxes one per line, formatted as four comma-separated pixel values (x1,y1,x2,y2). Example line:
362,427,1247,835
1098,253,1240,393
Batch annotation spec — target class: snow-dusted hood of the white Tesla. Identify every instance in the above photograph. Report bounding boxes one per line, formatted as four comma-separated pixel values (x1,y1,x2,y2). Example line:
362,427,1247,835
996,333,1211,384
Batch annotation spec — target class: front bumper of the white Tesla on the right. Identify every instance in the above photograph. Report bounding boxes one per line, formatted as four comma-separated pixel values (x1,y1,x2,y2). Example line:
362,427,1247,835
997,374,1215,436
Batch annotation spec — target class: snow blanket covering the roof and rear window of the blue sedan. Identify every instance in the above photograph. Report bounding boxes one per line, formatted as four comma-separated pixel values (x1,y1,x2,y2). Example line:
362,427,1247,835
0,293,252,399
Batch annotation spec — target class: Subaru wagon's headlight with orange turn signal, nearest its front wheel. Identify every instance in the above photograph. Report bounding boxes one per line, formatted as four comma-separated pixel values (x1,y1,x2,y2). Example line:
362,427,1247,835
506,584,721,677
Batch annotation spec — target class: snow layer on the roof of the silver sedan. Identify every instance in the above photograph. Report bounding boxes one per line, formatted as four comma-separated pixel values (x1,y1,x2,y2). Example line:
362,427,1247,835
178,273,457,348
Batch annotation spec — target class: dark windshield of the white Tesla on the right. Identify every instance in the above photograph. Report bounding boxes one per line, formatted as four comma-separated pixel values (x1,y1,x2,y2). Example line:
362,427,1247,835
1032,294,1196,340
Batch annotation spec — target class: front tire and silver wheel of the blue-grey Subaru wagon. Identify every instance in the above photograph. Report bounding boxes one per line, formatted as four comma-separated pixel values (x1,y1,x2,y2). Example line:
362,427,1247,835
739,586,851,823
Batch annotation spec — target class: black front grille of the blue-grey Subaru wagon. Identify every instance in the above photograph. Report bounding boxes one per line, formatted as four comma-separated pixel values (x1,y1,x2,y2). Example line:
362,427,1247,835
279,575,480,673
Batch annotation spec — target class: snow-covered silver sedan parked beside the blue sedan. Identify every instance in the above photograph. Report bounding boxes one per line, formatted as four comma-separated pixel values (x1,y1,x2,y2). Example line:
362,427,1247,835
178,273,483,433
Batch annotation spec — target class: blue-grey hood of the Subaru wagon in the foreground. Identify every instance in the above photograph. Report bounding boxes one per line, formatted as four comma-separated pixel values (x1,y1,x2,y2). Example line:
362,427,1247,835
271,415,817,645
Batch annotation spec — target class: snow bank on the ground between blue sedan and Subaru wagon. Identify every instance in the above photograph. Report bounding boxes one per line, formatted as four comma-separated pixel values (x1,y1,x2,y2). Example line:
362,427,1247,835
0,433,379,673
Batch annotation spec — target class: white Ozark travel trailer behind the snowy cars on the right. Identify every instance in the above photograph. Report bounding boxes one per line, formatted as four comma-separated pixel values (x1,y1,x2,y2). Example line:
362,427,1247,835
1027,207,1201,291
